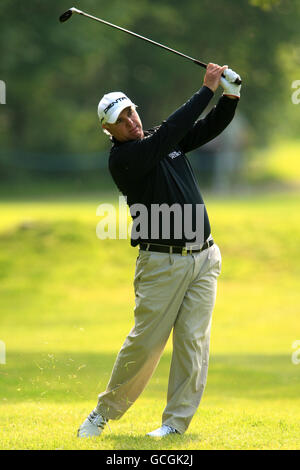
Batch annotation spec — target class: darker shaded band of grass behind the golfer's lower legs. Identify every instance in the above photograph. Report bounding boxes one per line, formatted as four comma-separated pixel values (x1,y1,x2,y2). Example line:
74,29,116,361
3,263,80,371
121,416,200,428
0,351,300,404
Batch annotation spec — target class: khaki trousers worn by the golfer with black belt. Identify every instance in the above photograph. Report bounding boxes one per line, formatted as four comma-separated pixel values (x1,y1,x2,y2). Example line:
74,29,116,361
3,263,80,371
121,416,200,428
96,244,221,433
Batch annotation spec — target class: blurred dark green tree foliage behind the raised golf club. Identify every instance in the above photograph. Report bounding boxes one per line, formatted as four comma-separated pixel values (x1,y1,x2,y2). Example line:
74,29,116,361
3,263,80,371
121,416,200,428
0,0,300,163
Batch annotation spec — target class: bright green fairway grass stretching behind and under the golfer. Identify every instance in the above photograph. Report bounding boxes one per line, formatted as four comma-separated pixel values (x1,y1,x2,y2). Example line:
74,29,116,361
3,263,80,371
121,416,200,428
0,192,300,450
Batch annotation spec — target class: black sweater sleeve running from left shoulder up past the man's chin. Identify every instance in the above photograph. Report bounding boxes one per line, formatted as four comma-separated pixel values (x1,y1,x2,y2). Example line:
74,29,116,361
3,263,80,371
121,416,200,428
110,86,213,180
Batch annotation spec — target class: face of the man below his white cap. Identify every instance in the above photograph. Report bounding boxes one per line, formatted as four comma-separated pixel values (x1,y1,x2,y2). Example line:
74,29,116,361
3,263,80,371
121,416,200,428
102,106,144,142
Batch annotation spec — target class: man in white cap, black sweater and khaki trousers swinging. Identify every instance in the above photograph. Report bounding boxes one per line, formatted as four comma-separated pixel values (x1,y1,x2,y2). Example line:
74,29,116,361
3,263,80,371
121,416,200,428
78,63,241,437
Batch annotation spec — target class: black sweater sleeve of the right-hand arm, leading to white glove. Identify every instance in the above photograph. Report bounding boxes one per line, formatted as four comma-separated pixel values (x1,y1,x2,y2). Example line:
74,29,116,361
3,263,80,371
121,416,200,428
179,96,239,153
